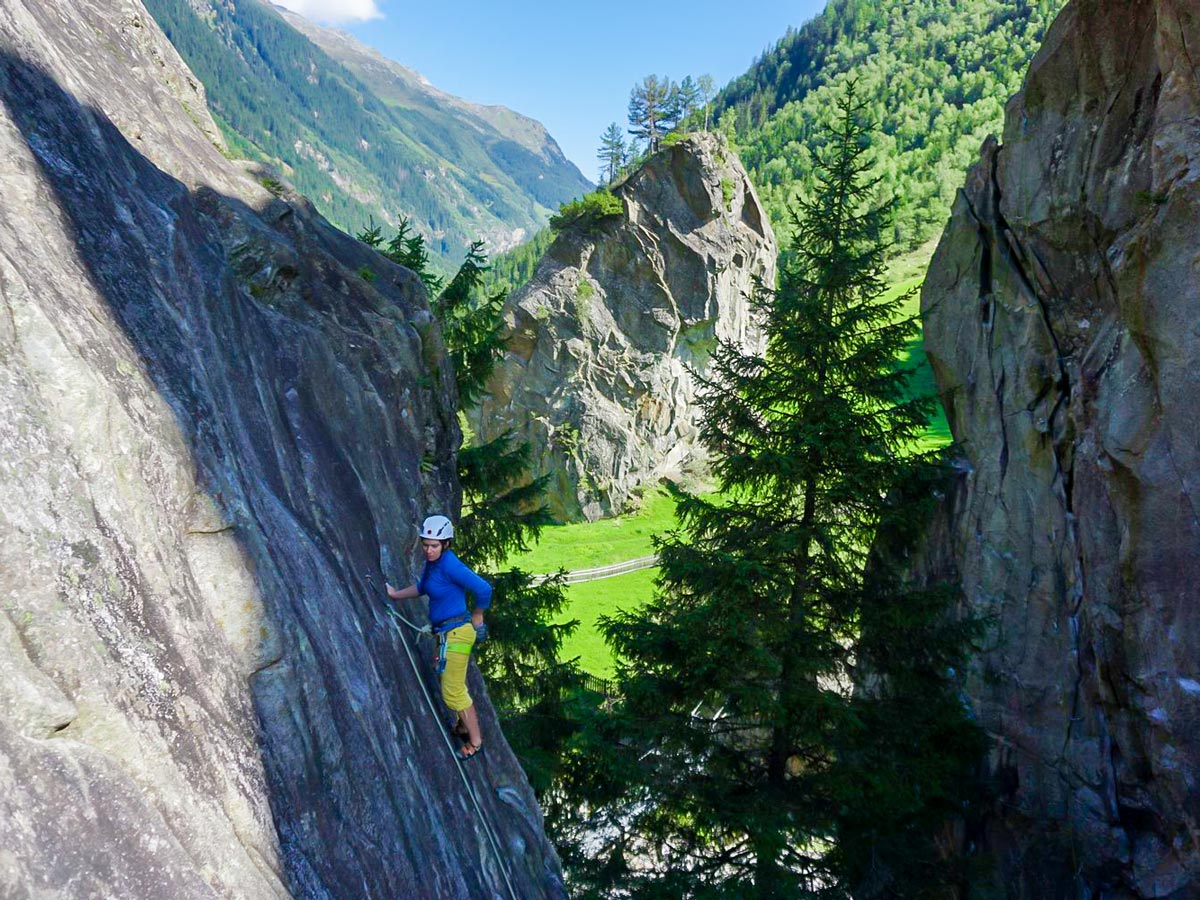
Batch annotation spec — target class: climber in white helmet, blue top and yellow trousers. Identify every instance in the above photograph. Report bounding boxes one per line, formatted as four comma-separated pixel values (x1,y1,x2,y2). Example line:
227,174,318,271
386,516,492,760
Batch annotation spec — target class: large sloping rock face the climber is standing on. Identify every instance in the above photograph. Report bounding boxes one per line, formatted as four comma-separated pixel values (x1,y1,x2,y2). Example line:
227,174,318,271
0,0,562,899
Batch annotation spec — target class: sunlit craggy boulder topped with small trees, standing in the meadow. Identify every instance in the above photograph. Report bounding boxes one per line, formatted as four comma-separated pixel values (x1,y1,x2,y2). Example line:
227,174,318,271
470,134,775,521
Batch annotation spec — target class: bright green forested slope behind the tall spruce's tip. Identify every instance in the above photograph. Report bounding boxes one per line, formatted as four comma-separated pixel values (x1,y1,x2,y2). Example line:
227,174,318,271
715,0,1063,248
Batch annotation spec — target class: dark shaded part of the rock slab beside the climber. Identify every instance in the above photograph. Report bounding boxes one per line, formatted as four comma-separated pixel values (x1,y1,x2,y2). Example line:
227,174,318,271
0,54,565,899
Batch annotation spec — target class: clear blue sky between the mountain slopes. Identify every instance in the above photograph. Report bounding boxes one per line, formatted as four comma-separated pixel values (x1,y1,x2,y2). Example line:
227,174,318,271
275,0,824,180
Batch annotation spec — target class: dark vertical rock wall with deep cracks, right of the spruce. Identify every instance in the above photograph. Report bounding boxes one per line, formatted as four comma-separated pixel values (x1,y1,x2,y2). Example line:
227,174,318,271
922,0,1200,900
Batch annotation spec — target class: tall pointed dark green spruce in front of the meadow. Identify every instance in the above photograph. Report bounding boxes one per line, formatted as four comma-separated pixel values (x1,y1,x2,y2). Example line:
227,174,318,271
600,92,978,900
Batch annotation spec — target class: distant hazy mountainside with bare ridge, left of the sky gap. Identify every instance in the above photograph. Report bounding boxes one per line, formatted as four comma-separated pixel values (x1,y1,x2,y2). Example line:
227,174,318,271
146,0,588,260
